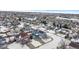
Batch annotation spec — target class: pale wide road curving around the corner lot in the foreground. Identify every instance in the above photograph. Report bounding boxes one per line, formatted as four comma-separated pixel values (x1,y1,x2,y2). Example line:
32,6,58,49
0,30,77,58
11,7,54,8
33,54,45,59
39,33,62,49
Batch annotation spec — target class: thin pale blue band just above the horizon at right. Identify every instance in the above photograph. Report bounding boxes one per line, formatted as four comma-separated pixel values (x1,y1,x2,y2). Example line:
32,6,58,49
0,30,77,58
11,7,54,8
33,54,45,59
32,10,79,14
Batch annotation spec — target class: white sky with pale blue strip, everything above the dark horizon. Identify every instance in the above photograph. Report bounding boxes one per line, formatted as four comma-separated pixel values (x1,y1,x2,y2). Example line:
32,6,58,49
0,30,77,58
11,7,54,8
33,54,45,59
0,0,79,14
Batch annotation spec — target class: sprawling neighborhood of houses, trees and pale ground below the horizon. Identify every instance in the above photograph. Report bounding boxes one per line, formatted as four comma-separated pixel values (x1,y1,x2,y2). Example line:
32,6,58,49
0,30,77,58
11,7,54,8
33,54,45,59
0,11,79,49
